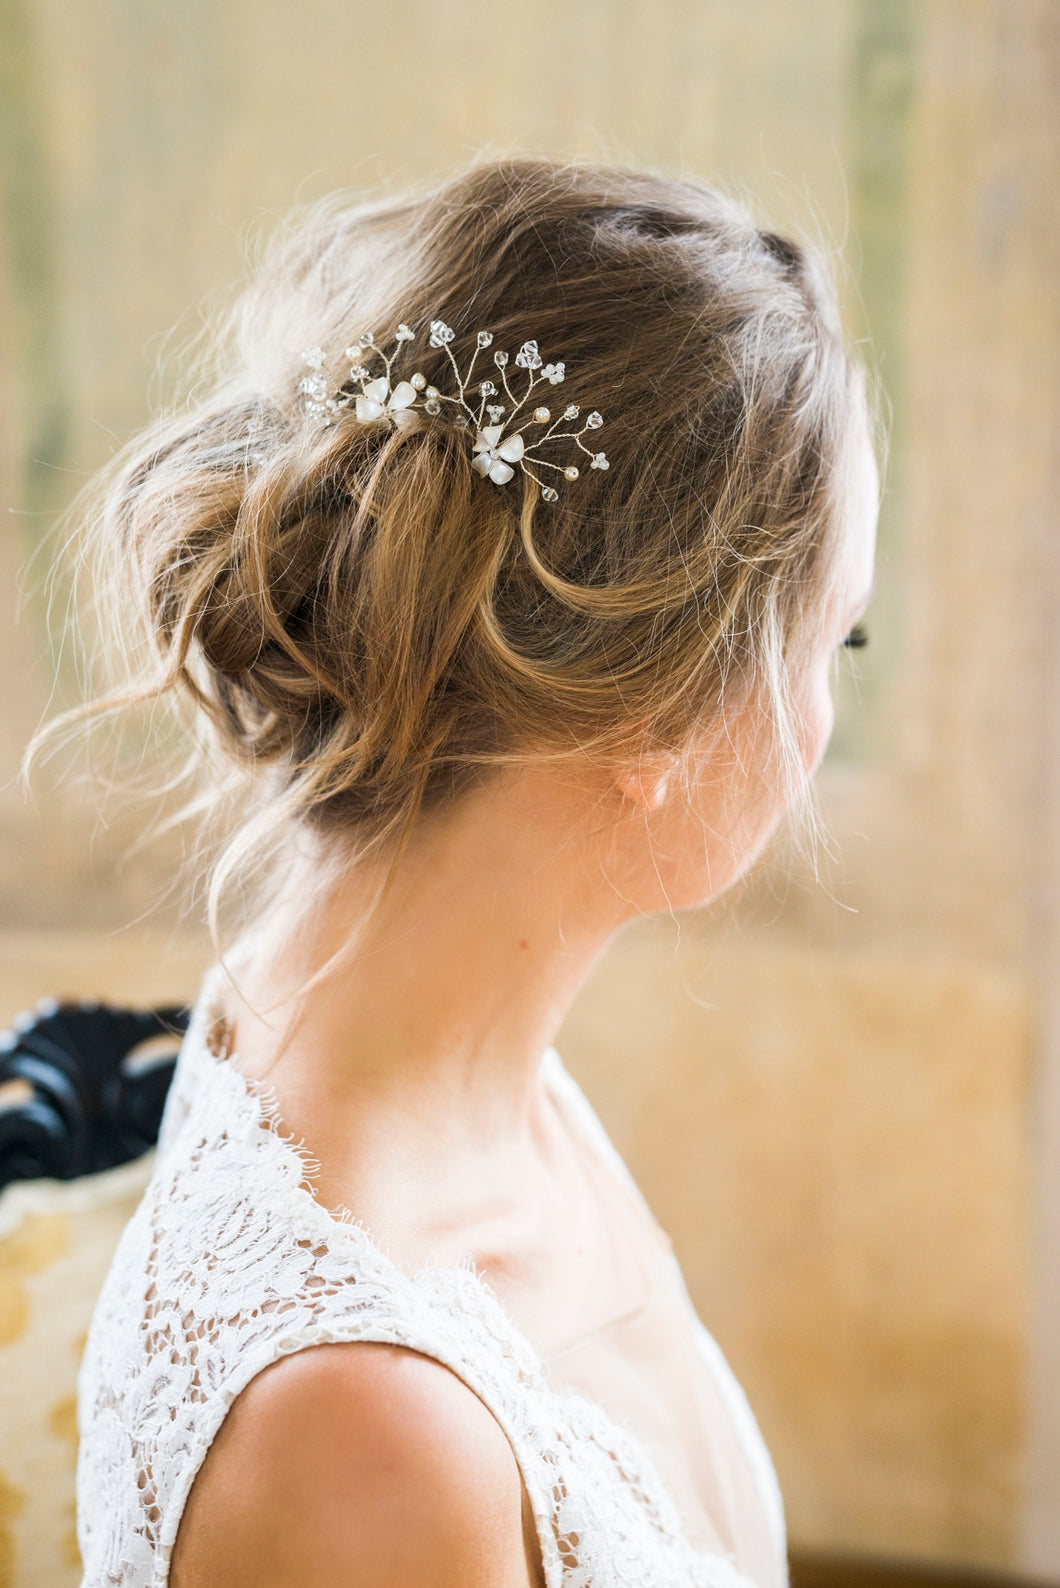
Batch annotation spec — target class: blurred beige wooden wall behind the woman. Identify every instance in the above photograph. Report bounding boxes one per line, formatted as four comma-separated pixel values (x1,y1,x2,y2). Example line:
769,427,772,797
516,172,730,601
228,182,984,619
0,0,1060,1588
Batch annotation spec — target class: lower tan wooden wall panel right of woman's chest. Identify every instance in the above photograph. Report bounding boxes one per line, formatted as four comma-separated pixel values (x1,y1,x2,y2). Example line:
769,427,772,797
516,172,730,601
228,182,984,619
560,924,1031,1566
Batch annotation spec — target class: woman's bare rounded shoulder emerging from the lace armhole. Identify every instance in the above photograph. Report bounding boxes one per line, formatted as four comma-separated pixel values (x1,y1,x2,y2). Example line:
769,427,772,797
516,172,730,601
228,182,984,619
170,1342,538,1588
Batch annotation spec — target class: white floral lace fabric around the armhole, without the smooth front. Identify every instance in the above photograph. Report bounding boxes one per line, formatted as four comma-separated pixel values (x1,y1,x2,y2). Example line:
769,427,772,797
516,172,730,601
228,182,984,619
78,978,771,1588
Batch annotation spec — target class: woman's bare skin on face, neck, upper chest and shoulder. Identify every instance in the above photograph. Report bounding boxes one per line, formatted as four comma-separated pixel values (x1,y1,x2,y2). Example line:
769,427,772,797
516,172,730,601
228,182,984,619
171,419,879,1588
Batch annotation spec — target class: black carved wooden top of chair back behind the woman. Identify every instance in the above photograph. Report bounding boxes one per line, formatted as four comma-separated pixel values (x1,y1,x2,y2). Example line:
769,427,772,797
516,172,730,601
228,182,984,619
0,999,190,1191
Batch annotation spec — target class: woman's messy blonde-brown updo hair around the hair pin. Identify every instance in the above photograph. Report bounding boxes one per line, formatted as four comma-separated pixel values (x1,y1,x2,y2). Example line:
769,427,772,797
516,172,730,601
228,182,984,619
35,159,865,946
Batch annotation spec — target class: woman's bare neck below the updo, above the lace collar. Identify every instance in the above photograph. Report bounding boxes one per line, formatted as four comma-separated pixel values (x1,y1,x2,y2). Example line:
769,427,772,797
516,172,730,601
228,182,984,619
215,769,635,1166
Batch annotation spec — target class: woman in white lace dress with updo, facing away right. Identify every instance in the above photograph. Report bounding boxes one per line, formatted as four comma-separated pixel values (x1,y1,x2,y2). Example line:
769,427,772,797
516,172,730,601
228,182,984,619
62,151,878,1588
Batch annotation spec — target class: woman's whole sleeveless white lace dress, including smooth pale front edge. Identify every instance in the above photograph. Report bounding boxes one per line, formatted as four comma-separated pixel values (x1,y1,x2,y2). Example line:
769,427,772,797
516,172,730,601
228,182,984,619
78,967,785,1588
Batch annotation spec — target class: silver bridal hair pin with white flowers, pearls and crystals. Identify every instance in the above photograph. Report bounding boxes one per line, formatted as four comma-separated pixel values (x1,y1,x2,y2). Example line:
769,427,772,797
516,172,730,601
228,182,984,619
298,319,609,502
